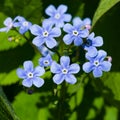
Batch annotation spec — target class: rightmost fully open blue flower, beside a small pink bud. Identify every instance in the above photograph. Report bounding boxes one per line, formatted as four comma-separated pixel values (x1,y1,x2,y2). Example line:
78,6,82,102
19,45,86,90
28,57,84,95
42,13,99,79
83,50,112,78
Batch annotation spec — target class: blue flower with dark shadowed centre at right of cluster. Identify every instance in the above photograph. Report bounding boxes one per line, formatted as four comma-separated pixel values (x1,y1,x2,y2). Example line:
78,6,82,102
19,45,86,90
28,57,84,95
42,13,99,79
83,32,103,57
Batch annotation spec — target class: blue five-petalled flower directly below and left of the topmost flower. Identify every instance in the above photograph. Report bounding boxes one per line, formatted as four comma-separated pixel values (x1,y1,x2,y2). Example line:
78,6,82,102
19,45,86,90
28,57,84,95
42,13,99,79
30,21,61,48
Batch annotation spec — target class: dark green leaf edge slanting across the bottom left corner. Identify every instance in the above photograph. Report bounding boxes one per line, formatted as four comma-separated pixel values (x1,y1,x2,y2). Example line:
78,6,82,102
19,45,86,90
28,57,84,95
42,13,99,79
0,87,19,120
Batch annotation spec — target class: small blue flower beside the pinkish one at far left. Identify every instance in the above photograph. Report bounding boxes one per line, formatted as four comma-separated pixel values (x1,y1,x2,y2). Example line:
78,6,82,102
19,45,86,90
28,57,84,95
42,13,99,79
14,16,32,34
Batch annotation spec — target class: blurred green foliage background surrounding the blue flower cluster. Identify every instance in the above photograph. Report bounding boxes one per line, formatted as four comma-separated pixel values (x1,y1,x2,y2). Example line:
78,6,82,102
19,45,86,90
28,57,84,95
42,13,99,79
0,0,120,120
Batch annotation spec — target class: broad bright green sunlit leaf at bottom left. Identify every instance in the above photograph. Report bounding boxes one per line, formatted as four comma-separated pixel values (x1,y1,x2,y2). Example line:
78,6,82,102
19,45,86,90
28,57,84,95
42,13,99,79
12,92,42,120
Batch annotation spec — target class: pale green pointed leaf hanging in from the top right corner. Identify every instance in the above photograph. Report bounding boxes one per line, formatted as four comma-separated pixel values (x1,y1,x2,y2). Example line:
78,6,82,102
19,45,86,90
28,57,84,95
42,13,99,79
92,0,120,27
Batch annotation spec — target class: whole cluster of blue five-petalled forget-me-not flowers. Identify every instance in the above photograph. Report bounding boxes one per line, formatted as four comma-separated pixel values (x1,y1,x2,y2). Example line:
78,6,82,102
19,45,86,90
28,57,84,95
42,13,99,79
0,5,112,87
